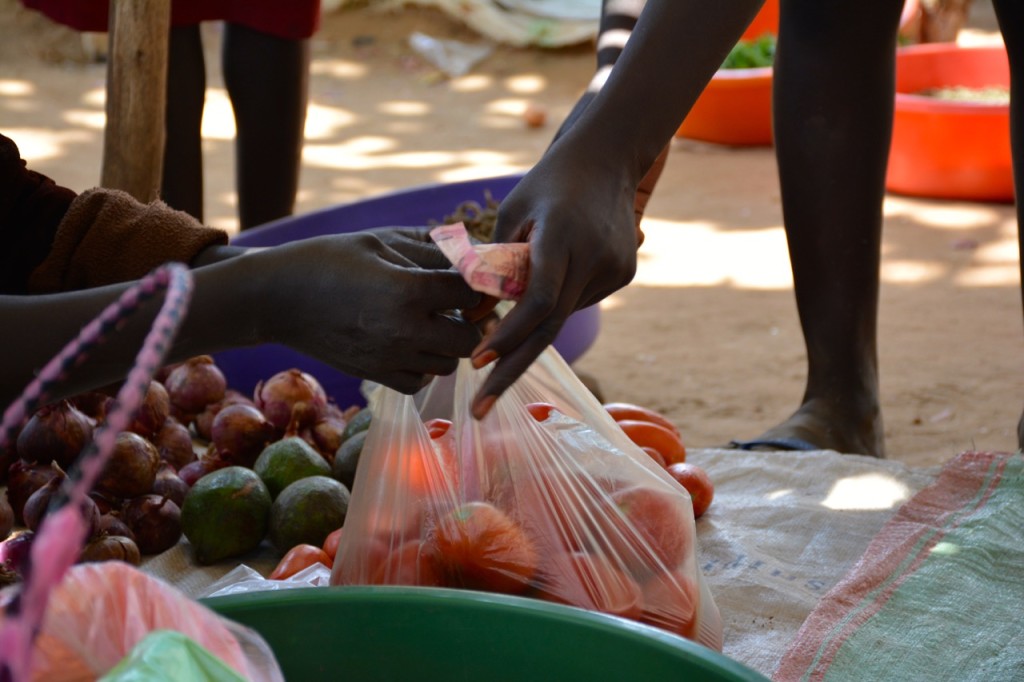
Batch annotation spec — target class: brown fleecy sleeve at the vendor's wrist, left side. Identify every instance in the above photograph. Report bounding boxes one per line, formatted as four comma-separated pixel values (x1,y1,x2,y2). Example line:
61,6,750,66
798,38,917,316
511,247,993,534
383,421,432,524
29,188,227,294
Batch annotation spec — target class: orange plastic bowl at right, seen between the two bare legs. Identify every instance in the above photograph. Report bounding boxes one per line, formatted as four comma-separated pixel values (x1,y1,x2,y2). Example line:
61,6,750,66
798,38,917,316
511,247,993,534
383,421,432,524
886,43,1014,202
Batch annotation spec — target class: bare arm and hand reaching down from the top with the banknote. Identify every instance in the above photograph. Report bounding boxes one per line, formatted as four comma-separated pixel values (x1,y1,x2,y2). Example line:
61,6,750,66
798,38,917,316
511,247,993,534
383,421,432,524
473,0,763,418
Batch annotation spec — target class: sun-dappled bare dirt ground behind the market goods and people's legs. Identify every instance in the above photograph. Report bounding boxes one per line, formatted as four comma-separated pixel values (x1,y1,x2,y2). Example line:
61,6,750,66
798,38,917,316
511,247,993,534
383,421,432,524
0,0,1024,465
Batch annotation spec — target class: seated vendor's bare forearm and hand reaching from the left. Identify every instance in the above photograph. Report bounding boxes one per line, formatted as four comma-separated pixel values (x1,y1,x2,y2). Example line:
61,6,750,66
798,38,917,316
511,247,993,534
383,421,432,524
0,230,479,406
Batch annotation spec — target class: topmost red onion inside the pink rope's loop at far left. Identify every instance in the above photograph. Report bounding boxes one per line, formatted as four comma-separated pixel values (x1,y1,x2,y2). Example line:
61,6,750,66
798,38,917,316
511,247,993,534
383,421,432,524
16,400,93,469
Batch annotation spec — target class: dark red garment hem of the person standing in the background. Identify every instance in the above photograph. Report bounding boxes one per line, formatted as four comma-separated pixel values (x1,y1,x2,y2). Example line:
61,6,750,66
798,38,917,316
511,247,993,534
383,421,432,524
22,0,321,40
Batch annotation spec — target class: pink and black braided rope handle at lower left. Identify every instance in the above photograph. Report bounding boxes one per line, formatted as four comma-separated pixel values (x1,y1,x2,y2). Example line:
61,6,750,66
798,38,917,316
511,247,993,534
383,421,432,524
0,263,193,682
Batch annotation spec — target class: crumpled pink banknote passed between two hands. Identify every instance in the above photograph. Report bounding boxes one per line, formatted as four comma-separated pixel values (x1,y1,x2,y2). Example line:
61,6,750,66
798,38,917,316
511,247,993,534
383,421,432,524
430,222,529,300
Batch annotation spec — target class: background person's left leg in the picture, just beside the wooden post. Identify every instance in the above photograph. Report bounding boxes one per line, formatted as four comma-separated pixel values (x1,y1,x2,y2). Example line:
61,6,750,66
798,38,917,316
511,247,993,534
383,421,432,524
161,25,206,220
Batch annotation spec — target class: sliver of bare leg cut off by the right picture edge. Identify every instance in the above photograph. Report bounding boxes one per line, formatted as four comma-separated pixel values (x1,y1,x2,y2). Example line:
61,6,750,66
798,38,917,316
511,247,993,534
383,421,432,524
992,0,1024,450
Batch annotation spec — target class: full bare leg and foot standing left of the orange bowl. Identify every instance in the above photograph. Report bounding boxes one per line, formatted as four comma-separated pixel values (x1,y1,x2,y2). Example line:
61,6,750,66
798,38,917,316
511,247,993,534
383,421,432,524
745,0,901,457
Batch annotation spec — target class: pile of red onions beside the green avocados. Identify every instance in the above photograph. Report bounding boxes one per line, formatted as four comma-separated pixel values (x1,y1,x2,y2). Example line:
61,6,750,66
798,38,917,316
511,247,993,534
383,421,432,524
0,355,358,573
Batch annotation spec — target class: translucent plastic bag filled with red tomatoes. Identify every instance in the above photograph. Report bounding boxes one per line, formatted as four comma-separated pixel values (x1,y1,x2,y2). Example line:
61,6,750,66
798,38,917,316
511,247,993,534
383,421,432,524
332,348,722,650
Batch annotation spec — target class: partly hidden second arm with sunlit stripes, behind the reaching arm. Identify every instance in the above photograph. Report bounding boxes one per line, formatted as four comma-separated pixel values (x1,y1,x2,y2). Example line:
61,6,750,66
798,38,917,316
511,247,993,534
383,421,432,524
552,0,669,231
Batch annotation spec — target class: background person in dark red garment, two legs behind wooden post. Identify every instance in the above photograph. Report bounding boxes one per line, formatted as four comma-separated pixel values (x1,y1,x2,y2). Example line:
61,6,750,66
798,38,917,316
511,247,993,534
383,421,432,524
22,0,321,229
